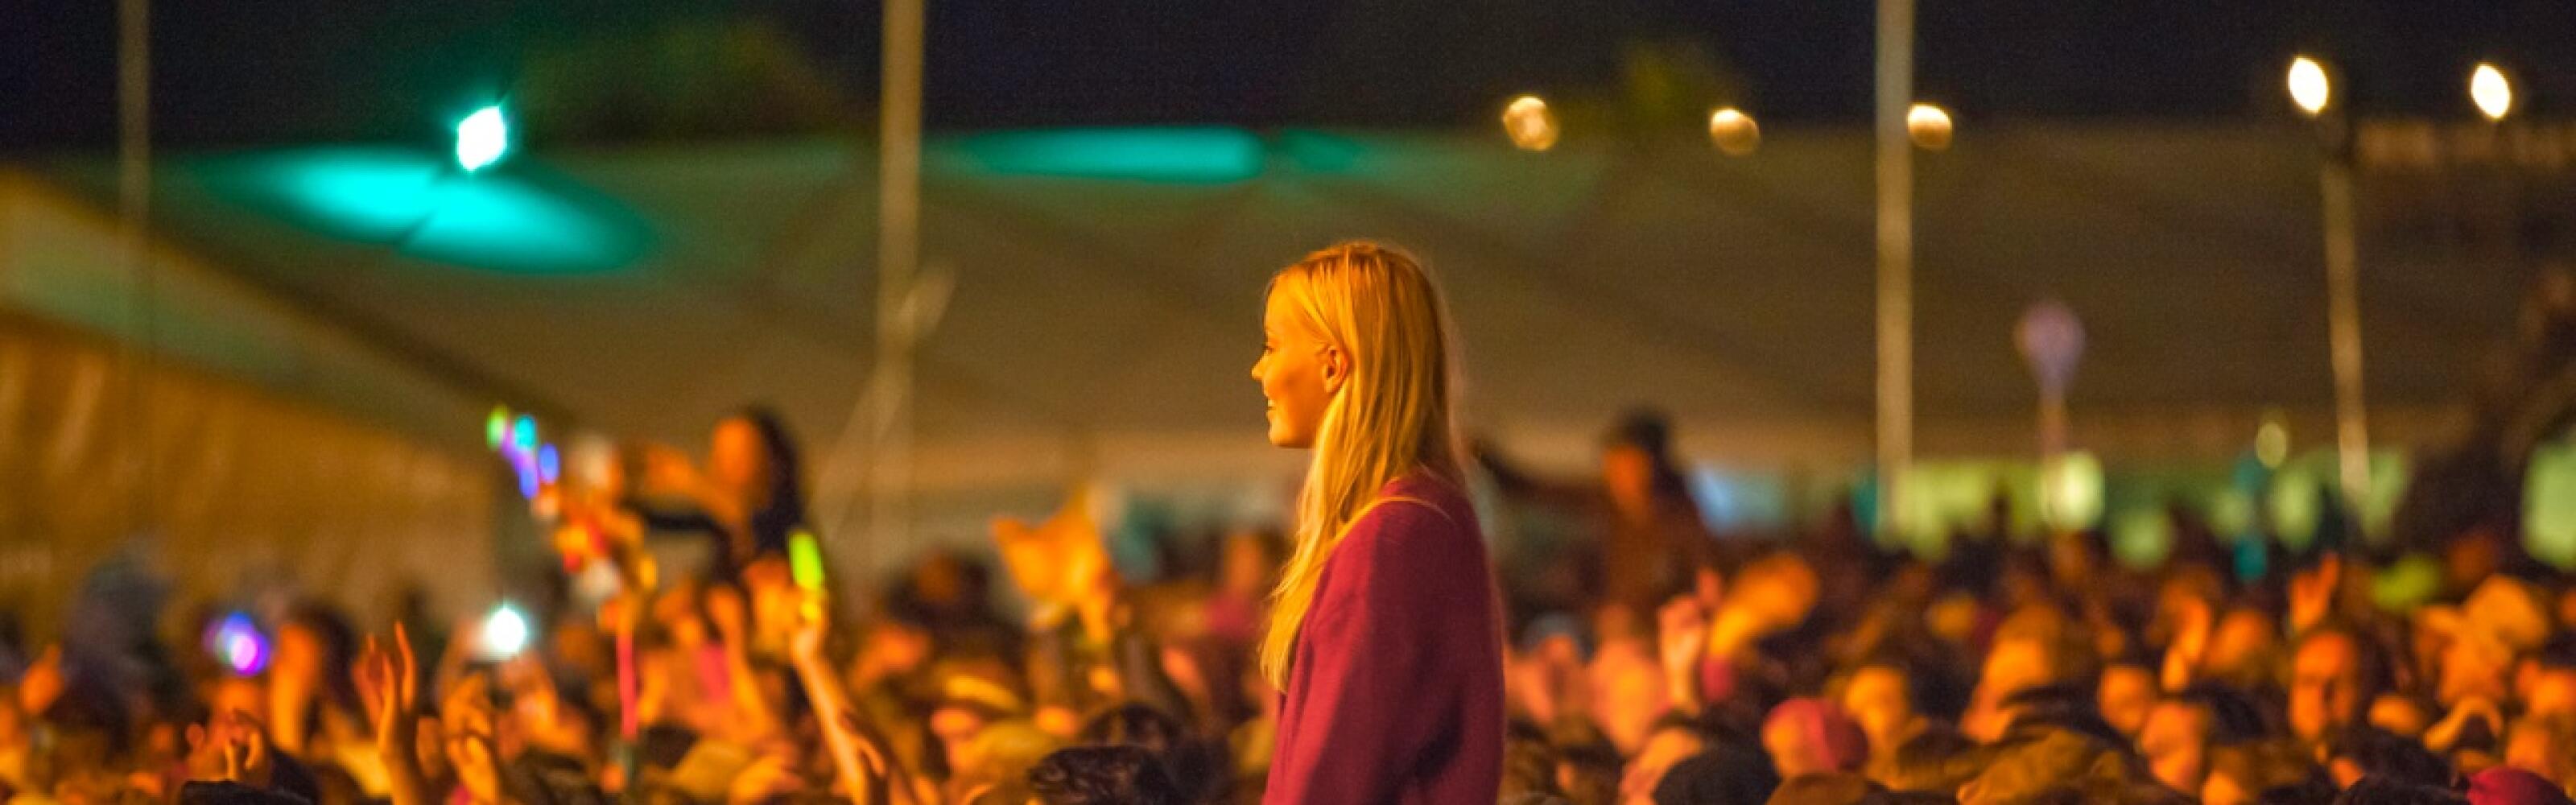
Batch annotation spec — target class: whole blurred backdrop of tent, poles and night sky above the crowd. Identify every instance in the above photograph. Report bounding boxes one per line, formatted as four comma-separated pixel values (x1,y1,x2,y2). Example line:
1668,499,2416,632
0,0,2576,621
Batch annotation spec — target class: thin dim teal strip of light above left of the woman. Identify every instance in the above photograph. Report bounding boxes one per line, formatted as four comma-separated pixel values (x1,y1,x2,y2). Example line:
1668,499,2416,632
953,126,1265,184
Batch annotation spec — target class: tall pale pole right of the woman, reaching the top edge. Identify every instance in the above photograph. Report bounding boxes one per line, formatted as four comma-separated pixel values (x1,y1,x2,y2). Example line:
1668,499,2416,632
1878,0,1914,534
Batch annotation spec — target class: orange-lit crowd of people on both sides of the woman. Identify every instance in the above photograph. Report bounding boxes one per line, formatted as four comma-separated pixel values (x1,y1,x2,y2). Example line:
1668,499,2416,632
0,399,2576,805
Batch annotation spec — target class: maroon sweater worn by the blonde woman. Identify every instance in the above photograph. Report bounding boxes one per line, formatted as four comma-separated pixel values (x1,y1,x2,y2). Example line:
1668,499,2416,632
1262,475,1502,805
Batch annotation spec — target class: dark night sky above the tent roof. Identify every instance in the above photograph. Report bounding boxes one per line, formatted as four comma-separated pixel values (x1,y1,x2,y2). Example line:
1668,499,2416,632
0,0,2576,150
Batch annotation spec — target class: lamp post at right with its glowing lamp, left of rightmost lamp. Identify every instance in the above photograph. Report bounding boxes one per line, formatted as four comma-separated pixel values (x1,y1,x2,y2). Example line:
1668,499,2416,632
2288,57,2370,514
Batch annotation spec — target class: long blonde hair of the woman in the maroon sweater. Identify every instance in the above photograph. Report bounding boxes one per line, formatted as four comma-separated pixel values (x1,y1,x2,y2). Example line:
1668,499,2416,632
1262,240,1460,689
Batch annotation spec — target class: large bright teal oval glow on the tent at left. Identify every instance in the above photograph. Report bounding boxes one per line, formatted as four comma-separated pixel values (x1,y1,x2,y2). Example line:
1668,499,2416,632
201,147,652,274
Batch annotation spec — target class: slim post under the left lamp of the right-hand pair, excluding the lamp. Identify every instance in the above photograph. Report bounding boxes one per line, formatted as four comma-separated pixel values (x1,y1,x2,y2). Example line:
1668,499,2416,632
2318,155,2370,514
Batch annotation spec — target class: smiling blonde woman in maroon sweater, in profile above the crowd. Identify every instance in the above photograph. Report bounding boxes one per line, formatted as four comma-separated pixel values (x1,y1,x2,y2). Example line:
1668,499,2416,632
1252,242,1505,805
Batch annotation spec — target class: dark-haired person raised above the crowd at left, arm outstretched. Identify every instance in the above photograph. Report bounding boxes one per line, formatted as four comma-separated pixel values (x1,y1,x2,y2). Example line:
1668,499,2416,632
626,405,807,580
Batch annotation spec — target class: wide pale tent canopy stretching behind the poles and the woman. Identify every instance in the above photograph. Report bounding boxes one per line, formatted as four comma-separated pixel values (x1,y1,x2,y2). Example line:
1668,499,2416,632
10,124,2529,521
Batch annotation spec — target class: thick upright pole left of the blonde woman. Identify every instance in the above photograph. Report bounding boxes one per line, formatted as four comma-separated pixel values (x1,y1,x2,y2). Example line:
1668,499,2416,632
861,0,925,576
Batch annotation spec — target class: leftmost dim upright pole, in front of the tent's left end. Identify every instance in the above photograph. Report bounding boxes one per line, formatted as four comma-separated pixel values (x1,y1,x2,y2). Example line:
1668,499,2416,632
116,0,155,534
